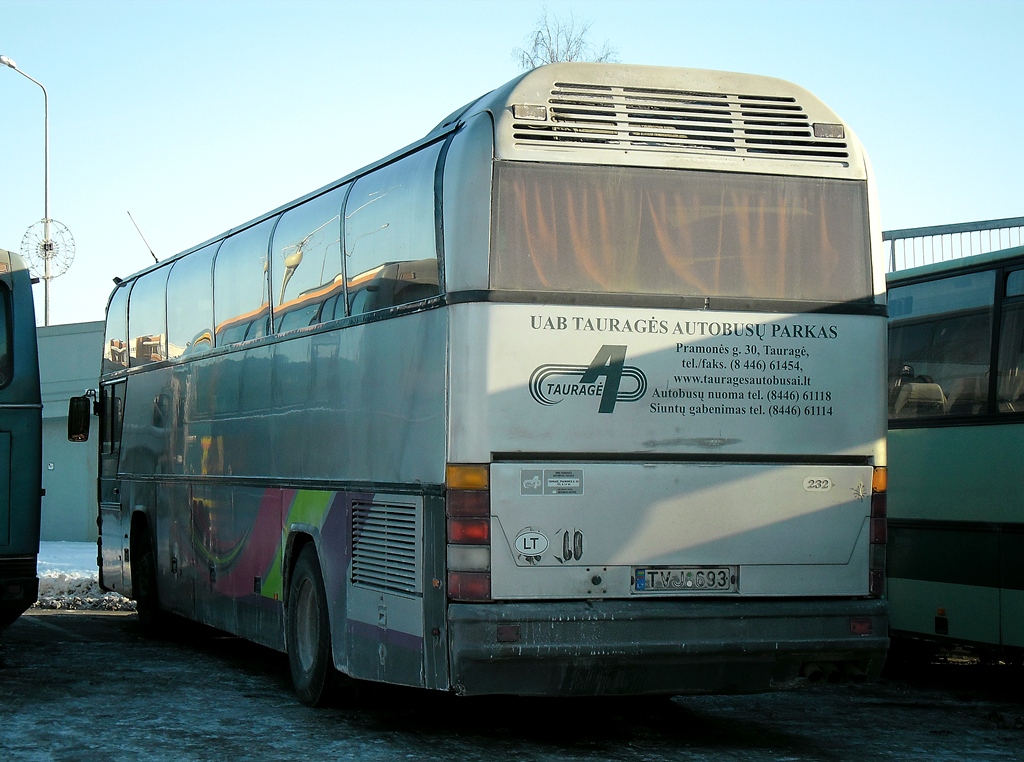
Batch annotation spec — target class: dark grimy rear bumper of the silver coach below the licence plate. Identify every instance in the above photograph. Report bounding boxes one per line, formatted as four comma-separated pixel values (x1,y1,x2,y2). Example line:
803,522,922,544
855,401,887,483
449,599,889,695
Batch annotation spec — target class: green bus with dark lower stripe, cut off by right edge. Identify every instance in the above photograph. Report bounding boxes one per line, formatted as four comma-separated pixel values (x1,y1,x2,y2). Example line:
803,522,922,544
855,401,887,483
886,218,1024,660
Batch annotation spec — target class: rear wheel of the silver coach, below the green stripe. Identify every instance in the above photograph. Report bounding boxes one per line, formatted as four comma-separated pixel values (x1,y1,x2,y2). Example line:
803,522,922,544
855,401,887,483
286,545,335,707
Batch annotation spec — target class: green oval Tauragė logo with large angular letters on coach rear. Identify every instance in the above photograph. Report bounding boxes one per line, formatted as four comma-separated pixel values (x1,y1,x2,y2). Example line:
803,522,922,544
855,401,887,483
529,344,647,413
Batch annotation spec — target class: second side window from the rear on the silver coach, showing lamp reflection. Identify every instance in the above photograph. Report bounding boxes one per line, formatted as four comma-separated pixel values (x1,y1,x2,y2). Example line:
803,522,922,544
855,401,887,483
271,186,347,331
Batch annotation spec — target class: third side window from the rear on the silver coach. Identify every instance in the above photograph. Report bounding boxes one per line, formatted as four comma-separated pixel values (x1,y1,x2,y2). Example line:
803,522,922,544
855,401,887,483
213,218,274,346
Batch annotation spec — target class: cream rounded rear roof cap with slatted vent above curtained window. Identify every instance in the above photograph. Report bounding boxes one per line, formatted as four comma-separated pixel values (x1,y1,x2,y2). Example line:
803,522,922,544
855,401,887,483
448,64,867,179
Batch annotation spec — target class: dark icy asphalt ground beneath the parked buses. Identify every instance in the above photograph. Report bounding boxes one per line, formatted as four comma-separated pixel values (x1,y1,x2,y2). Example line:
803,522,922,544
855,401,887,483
0,610,1024,762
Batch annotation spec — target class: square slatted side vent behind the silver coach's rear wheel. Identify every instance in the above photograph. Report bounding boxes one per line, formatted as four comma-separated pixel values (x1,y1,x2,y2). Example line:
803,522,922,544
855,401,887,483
352,503,421,593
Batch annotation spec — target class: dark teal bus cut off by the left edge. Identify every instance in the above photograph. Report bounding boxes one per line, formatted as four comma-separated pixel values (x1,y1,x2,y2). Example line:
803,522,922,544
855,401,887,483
0,249,43,630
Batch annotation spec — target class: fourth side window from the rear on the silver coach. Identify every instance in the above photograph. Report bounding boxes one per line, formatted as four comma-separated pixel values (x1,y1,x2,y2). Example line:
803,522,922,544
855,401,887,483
167,244,217,357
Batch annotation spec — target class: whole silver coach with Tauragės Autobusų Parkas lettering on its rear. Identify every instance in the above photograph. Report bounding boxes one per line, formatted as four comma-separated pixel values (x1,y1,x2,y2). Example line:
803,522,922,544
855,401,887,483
72,64,888,704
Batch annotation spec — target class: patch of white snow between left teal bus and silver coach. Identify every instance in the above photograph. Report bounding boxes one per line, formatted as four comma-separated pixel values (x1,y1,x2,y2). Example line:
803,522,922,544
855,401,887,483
32,542,135,611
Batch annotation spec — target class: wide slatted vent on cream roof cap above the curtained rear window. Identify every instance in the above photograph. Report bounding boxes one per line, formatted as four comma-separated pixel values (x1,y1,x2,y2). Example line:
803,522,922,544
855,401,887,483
512,82,849,164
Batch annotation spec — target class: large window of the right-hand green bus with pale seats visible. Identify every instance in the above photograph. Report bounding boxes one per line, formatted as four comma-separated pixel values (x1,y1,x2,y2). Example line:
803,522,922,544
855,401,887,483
889,271,995,419
